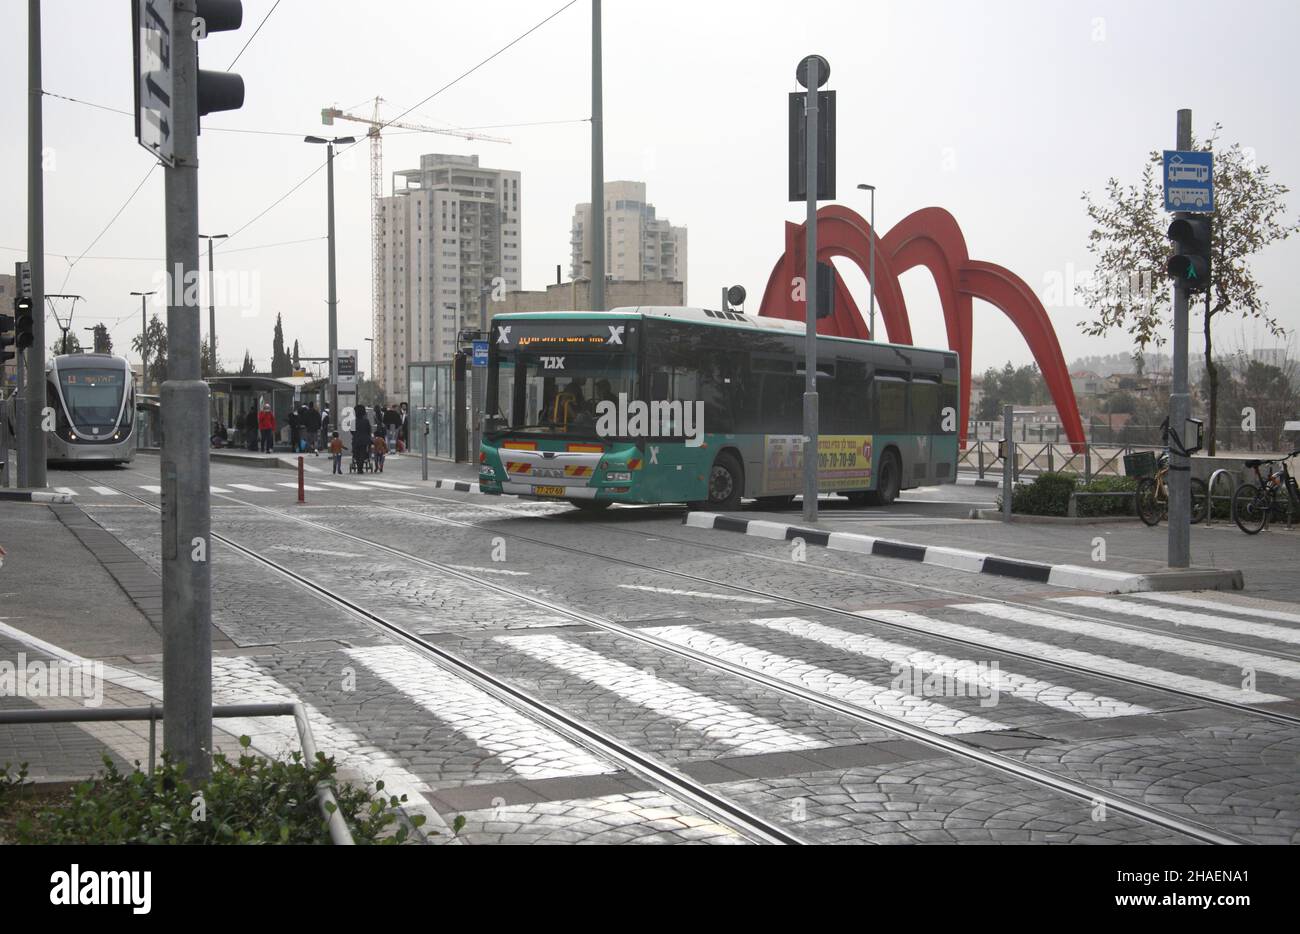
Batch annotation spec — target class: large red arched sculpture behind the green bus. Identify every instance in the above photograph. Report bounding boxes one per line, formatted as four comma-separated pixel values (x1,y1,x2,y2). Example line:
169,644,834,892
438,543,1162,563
758,204,1084,449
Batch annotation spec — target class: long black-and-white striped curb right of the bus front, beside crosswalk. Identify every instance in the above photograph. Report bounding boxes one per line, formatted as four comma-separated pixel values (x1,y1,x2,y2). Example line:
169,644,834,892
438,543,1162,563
685,513,1164,593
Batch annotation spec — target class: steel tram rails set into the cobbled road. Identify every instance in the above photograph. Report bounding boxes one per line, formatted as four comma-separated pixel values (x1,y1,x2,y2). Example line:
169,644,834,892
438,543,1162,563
76,470,1253,846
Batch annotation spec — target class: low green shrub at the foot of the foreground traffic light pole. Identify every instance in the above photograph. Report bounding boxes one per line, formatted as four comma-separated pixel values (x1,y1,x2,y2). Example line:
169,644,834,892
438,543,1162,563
17,736,424,844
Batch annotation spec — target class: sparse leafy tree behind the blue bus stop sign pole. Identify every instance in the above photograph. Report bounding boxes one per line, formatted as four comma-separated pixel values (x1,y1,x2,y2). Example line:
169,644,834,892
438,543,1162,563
1079,124,1300,454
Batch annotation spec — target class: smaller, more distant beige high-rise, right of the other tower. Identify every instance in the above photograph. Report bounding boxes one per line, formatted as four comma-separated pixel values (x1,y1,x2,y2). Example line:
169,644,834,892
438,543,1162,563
569,182,686,294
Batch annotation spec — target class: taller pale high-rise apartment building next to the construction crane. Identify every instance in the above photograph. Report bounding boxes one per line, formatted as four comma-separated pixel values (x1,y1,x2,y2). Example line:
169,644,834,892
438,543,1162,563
374,153,524,399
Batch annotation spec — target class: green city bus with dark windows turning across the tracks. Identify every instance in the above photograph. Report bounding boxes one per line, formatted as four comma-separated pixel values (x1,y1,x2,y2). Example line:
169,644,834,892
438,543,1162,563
478,307,958,510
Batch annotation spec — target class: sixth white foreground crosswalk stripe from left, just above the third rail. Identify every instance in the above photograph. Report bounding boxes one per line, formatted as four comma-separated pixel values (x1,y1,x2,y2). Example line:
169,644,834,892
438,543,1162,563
862,607,1287,704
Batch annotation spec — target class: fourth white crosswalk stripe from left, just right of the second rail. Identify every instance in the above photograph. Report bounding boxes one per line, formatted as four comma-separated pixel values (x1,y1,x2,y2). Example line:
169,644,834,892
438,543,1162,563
646,620,1009,735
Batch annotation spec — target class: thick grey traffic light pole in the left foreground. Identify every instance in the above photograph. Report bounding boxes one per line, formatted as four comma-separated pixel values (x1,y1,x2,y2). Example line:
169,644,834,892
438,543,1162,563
161,0,212,781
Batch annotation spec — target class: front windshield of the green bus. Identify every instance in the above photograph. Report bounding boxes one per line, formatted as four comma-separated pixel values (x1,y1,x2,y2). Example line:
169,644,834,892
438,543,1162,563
486,350,636,436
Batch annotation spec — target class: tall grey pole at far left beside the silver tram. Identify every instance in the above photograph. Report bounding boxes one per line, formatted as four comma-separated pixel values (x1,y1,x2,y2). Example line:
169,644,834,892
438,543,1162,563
20,0,46,487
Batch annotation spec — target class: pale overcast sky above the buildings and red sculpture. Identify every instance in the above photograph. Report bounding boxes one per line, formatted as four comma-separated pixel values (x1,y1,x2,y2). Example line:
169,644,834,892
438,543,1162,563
0,0,1300,371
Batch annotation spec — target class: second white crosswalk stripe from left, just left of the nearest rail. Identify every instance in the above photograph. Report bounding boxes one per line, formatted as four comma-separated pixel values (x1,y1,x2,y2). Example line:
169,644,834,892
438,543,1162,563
347,645,615,778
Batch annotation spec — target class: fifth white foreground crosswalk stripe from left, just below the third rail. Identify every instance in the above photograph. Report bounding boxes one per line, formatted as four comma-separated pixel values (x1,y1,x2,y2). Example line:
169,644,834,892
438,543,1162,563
749,617,1151,718
